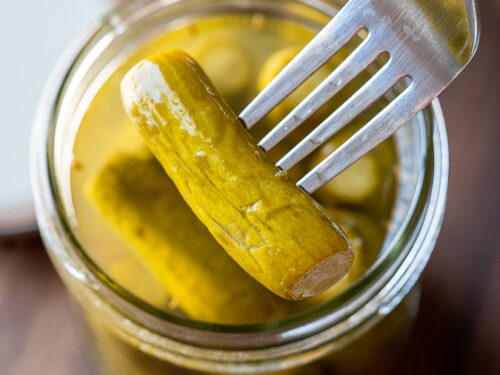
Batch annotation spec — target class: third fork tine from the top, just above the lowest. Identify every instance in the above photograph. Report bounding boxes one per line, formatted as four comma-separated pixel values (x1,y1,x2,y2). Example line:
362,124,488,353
276,57,403,170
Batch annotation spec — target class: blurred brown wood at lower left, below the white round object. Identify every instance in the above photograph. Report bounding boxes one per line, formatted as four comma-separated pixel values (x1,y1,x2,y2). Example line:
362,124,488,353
0,235,94,375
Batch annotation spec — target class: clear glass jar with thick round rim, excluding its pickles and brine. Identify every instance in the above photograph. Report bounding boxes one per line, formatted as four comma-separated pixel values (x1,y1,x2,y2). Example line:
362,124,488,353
32,0,448,374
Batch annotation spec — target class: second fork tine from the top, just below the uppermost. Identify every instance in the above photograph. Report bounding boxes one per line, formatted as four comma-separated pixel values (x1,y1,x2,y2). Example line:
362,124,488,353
259,34,380,151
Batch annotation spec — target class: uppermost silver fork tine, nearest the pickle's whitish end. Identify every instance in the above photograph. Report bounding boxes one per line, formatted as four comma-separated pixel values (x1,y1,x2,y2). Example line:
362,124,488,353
240,1,363,129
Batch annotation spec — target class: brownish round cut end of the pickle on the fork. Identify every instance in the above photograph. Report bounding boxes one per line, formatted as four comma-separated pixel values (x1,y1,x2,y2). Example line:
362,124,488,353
290,249,354,300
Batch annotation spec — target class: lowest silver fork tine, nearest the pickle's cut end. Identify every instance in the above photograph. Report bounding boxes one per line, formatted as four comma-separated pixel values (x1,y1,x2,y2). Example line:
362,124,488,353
297,83,420,194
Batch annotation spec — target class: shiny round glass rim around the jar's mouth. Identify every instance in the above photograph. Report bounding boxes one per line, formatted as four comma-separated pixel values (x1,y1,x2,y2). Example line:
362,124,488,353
31,0,448,347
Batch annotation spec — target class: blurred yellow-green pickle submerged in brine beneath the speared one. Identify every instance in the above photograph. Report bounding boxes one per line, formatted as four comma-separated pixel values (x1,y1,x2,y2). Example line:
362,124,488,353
86,150,294,324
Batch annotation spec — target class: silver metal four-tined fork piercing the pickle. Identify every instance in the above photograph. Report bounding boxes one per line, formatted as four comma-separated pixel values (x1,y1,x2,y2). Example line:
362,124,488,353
240,0,479,193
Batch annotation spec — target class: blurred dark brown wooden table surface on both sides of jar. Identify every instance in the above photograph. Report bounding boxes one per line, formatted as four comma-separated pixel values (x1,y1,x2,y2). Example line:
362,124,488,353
0,0,500,375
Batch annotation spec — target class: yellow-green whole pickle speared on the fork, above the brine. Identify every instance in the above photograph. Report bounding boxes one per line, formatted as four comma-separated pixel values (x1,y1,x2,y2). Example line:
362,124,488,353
121,49,354,300
